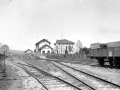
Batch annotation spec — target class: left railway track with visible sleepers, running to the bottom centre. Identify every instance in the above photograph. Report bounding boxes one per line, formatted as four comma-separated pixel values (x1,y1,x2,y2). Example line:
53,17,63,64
11,58,92,90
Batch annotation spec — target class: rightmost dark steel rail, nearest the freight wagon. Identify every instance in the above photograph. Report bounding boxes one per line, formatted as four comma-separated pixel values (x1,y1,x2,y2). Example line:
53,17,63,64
54,61,120,88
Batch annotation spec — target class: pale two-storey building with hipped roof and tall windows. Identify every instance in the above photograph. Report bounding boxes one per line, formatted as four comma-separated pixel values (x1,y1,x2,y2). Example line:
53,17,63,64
54,39,75,54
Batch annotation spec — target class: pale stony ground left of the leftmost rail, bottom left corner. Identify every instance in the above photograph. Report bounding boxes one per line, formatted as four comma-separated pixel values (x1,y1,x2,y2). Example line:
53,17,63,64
0,58,42,90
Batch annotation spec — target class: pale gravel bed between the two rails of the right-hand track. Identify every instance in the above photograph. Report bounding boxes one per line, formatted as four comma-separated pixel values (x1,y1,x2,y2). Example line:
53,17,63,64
53,62,119,90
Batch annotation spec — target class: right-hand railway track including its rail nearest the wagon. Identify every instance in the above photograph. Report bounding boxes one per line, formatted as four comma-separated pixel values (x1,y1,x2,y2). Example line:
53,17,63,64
51,61,120,90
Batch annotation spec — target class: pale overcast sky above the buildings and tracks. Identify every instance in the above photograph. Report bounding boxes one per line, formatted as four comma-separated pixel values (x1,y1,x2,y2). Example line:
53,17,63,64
0,0,120,50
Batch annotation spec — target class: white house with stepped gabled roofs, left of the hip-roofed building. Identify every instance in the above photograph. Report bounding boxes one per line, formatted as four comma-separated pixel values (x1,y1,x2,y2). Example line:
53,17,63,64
35,39,53,55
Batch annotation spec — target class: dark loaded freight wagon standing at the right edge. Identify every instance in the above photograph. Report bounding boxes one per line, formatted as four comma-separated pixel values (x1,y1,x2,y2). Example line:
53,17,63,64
90,41,120,66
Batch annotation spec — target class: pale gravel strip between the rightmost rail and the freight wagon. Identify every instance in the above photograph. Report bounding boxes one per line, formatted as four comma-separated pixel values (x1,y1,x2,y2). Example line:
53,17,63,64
62,62,120,84
